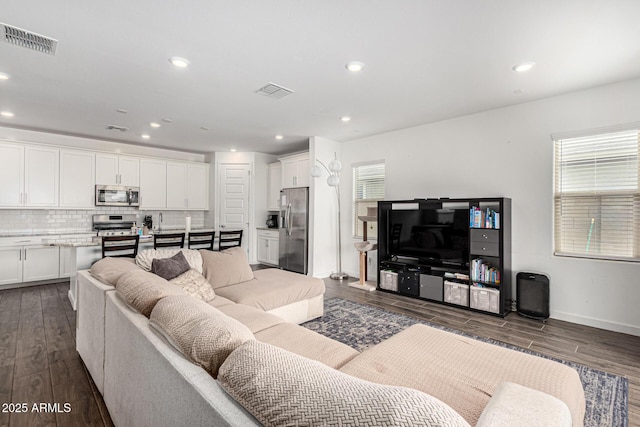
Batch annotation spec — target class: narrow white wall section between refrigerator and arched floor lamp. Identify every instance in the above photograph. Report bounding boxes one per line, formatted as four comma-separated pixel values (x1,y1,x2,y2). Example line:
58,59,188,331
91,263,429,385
309,136,342,277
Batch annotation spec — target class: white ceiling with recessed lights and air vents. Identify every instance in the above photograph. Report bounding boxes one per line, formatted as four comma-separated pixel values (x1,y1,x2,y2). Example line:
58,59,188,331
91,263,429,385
0,0,640,154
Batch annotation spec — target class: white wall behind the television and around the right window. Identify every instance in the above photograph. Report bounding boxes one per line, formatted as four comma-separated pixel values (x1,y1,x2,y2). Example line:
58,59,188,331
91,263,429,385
342,80,640,335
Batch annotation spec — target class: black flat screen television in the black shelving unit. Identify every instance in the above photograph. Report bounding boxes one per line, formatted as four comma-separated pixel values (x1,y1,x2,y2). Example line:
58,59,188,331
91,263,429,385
387,203,469,269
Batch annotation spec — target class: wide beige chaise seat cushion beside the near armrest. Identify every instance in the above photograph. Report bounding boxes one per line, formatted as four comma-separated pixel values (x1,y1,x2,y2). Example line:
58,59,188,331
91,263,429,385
340,324,585,426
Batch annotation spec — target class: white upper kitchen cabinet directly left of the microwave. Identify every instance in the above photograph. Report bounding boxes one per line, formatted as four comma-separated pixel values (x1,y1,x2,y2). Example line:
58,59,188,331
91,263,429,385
59,150,95,209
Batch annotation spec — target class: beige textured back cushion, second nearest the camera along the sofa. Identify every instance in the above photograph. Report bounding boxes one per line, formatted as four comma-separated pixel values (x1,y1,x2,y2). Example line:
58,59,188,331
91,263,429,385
150,296,254,378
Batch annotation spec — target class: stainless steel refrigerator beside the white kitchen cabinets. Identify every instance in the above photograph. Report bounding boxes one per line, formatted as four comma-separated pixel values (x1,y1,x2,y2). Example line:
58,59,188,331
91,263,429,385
279,187,309,274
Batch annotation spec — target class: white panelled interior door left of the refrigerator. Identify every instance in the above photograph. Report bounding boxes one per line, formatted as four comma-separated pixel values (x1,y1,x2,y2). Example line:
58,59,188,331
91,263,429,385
218,163,251,252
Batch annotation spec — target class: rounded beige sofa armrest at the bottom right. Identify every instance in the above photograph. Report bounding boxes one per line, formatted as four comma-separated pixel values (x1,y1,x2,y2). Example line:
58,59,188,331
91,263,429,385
476,382,571,427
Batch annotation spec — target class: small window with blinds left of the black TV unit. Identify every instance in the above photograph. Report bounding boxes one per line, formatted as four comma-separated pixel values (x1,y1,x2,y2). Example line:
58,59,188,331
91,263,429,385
353,162,384,239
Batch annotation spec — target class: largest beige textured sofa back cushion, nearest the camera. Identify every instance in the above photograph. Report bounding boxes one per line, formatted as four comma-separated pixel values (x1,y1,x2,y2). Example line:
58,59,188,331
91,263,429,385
219,341,469,426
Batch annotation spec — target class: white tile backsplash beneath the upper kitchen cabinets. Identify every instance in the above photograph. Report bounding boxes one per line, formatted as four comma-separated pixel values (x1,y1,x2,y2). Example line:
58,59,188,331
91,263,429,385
0,207,210,234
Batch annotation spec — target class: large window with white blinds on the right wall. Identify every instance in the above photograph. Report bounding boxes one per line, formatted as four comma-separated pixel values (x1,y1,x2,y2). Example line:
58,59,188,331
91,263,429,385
554,129,640,261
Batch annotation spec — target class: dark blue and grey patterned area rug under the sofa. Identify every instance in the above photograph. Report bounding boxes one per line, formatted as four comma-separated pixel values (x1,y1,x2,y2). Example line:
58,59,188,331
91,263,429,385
302,298,628,427
